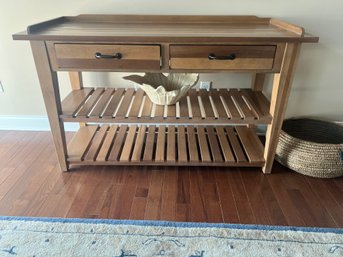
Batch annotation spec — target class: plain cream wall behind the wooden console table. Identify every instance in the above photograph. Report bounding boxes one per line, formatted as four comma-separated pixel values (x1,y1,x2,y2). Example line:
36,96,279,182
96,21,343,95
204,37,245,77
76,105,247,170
0,0,343,126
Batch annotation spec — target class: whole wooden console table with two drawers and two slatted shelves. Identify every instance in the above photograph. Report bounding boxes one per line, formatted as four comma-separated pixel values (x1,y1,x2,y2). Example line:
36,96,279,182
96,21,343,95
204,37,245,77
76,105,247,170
13,15,318,173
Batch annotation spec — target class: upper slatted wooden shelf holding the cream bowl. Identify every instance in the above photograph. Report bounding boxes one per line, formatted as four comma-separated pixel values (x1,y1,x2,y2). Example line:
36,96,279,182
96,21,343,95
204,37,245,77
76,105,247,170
61,88,271,124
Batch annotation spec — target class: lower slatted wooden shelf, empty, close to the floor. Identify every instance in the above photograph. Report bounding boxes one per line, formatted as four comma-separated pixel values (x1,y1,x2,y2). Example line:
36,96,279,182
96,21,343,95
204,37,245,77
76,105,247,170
68,124,264,167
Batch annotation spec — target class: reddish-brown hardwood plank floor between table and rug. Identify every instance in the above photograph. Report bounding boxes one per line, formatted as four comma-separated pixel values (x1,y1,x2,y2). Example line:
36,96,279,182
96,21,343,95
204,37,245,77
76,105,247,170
0,131,343,227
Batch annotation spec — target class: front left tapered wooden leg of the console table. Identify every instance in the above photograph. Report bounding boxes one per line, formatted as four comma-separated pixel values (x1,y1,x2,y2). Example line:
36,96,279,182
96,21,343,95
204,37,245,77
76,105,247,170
30,41,68,171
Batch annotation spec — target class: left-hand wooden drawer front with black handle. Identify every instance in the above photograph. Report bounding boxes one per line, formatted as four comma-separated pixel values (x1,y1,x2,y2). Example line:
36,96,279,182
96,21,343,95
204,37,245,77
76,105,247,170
54,44,161,70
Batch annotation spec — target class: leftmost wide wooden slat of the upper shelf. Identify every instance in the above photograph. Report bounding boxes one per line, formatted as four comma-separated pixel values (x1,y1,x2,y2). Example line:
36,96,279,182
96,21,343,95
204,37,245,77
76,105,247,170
62,88,94,116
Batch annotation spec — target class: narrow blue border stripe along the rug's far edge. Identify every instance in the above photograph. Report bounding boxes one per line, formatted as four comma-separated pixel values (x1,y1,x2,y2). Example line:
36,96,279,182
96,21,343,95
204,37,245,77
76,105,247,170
0,216,343,234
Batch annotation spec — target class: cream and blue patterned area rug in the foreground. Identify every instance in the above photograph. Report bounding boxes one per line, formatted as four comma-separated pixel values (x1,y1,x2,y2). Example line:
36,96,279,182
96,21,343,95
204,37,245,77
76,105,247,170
0,217,343,254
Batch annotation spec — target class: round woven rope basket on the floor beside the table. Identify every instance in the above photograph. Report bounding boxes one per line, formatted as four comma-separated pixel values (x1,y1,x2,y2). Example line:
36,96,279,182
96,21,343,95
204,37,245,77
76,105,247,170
275,119,343,178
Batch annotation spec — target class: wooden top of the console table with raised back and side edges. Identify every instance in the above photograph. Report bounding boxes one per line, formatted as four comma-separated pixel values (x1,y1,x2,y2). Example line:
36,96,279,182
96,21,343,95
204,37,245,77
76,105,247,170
13,15,318,43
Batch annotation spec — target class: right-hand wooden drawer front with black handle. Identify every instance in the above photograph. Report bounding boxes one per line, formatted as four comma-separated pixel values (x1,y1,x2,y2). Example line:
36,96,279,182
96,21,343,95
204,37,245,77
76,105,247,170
170,45,276,70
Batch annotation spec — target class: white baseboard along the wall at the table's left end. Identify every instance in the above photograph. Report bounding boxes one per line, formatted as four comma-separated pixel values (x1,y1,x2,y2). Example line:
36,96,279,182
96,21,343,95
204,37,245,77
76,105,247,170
0,116,79,131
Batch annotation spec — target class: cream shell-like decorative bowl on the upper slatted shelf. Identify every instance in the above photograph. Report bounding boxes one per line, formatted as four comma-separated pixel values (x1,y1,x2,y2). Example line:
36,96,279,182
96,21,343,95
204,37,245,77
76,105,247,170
123,73,199,105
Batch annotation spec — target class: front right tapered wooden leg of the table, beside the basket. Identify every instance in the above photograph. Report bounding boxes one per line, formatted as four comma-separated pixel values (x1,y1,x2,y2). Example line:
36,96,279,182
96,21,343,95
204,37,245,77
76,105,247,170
262,43,300,173
